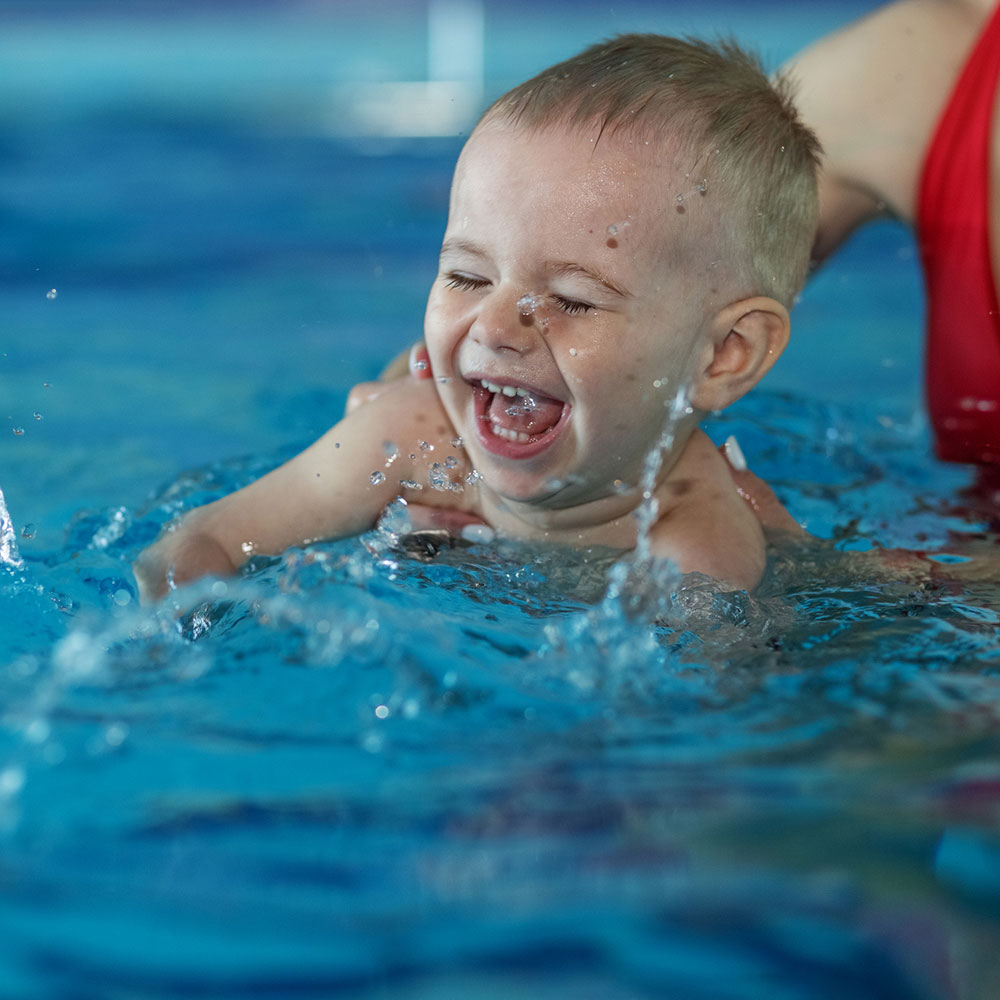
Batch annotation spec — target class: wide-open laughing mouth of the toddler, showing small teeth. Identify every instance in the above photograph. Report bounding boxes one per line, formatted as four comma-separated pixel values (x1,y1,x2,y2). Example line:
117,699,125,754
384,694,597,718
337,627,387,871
472,379,570,458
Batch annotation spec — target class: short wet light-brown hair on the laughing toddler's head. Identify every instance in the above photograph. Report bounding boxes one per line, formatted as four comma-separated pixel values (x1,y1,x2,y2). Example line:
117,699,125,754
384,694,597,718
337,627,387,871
482,34,820,306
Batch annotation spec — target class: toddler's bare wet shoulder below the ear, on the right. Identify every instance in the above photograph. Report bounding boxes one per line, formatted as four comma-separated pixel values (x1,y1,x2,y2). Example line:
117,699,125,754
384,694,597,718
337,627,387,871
650,430,766,590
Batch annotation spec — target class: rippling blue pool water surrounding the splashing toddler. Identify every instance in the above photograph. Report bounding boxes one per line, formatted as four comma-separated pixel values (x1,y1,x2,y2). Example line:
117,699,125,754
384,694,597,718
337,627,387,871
0,2,1000,1000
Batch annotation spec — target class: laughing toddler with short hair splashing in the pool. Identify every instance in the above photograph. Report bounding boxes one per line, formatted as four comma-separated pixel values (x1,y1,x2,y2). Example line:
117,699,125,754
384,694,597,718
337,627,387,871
135,35,818,600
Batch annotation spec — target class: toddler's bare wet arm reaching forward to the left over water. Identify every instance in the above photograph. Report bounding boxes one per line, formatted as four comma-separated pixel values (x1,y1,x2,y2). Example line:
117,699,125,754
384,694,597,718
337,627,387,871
133,380,454,601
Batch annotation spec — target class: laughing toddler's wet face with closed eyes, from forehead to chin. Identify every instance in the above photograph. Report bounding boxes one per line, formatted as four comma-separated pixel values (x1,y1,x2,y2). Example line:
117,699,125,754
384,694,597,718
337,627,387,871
425,124,717,508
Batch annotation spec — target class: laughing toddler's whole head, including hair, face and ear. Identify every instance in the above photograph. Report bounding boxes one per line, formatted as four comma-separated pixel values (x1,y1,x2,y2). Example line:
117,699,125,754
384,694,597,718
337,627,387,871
425,36,816,511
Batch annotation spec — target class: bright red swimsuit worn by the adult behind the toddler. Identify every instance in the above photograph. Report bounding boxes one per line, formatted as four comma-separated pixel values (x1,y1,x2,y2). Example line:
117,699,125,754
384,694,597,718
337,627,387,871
917,5,1000,463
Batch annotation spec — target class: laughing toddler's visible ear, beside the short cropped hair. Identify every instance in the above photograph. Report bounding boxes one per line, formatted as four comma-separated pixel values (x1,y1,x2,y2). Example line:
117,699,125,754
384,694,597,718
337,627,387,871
691,296,791,412
